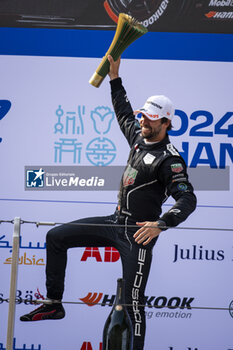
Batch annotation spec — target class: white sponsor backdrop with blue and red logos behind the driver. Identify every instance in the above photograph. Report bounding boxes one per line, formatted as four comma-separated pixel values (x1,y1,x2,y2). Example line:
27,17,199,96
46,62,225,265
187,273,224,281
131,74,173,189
0,56,233,350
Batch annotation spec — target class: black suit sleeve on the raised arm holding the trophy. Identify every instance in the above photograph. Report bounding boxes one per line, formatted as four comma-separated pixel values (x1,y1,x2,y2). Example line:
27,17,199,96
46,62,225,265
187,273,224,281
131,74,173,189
110,78,140,147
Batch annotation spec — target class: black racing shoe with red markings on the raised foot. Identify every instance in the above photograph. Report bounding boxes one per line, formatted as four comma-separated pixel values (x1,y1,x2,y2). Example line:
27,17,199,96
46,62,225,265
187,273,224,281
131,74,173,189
20,303,65,321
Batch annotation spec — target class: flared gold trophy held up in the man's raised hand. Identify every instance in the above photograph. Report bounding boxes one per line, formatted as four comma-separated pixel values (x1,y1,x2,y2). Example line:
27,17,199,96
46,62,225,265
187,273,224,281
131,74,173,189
89,13,148,87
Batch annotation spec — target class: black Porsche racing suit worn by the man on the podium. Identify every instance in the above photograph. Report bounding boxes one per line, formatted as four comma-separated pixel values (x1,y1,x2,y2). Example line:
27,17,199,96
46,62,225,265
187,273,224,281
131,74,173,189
46,78,196,350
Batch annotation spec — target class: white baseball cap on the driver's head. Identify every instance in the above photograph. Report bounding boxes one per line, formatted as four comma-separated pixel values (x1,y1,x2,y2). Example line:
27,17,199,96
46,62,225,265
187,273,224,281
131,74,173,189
134,95,174,120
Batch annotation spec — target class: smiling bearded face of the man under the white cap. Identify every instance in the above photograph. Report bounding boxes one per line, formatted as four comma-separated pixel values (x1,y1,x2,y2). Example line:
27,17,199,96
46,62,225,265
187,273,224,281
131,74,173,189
140,114,169,142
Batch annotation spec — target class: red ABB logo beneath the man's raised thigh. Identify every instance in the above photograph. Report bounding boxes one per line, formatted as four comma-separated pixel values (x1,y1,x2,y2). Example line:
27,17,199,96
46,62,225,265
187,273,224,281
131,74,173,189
81,247,120,262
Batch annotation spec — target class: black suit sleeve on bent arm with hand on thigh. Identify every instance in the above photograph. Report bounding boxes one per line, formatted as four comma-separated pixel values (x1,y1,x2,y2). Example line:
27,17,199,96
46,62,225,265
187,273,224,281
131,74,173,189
158,157,197,227
